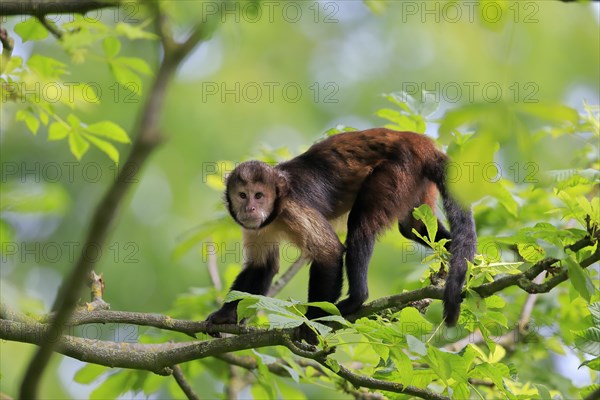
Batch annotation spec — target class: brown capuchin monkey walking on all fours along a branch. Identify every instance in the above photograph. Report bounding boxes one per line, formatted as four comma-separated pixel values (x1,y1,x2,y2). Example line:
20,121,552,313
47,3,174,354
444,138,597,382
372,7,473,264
207,128,476,342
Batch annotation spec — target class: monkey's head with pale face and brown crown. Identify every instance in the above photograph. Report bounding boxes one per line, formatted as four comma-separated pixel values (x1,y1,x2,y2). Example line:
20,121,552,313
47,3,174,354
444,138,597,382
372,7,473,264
225,161,288,229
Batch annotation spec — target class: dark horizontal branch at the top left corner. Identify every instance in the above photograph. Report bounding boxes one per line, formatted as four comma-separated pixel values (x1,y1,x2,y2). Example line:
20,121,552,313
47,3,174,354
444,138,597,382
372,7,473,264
0,0,122,16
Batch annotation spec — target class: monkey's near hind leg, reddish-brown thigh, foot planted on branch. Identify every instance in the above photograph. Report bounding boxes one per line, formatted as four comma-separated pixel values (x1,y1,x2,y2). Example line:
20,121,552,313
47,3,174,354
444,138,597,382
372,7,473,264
338,163,415,315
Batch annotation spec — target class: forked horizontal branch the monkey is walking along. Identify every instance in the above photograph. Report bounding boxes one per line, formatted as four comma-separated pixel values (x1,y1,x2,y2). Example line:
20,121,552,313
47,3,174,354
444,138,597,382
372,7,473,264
0,231,600,399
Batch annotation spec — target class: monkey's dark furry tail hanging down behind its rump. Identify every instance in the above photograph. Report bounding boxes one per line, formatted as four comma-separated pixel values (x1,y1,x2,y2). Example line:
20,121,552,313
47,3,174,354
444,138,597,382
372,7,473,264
425,152,477,326
